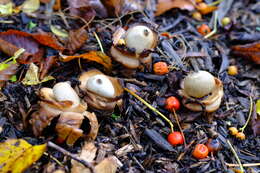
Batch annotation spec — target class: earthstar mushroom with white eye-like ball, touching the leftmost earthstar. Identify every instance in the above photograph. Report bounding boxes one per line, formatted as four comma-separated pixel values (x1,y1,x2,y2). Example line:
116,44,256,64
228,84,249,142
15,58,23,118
79,70,123,111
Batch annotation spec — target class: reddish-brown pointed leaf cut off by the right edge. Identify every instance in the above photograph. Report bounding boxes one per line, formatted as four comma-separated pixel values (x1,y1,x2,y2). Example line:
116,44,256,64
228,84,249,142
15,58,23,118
231,42,260,64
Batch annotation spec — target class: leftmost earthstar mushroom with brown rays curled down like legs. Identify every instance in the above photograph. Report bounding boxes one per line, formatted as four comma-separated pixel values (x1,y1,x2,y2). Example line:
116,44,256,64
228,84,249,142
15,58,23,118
31,82,96,145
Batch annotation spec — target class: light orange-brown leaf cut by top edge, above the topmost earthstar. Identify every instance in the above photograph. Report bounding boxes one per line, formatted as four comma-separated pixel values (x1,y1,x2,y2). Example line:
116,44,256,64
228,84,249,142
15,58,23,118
155,0,195,16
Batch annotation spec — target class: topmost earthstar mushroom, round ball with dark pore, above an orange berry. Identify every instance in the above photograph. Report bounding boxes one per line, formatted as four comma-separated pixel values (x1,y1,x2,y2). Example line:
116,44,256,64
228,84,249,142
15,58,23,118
110,25,158,69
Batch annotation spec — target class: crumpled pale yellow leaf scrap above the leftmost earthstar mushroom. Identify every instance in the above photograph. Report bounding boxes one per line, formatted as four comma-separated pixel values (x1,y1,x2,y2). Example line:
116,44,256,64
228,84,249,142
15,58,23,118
22,63,54,85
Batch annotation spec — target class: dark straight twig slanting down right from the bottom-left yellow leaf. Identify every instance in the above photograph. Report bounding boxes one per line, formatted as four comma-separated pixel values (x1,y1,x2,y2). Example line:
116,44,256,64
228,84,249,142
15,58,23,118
47,141,95,173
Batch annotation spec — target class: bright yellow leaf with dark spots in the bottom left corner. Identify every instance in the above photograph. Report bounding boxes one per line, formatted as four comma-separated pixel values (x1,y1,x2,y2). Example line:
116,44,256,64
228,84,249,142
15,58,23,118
0,139,46,173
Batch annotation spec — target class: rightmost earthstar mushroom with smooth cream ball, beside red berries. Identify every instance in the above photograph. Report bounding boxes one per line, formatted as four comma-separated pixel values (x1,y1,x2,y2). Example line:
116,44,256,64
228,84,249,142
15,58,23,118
179,71,223,112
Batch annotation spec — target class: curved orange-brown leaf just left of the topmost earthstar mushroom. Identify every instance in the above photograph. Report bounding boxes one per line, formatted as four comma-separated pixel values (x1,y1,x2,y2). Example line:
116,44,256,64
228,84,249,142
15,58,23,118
60,51,112,69
